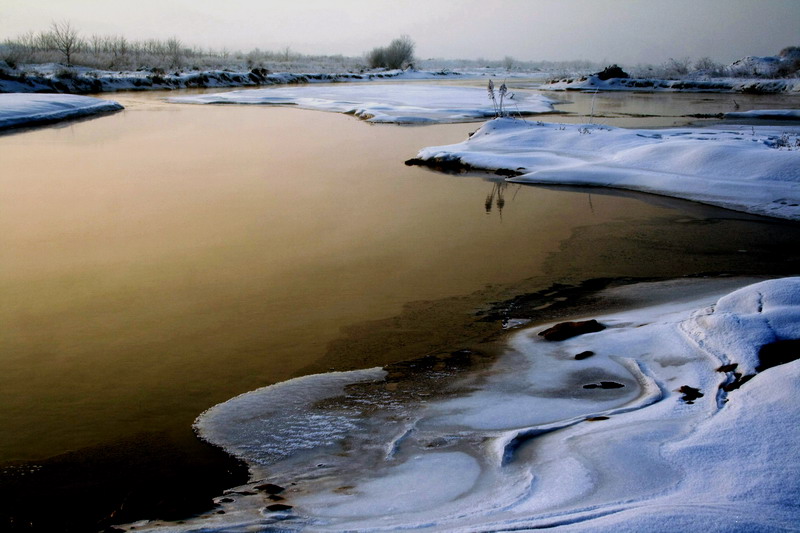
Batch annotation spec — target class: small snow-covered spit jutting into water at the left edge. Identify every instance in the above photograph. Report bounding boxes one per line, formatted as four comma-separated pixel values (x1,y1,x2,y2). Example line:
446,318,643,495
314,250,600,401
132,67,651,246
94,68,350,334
0,93,122,130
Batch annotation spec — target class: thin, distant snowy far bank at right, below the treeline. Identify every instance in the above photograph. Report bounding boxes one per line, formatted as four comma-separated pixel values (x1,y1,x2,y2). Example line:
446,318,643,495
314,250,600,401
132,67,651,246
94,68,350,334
538,75,800,94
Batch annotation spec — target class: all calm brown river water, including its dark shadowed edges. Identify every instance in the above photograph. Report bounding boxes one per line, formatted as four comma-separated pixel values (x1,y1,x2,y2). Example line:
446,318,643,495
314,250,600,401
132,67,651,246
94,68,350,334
0,86,800,530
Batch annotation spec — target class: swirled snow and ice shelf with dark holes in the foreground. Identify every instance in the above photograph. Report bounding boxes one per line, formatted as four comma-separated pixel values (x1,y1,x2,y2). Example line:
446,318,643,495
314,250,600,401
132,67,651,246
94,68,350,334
123,278,800,532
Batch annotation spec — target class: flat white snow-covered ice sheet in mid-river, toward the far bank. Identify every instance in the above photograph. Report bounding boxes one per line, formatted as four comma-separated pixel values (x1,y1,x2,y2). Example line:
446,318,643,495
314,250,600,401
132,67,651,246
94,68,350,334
169,84,554,124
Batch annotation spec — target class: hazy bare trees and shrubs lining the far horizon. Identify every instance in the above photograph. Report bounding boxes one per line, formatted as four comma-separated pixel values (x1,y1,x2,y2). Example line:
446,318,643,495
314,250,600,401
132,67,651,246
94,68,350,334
7,21,800,79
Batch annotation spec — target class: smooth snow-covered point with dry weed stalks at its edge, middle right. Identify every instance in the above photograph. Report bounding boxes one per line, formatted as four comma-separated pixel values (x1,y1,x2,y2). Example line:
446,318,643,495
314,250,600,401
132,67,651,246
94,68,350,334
416,118,800,220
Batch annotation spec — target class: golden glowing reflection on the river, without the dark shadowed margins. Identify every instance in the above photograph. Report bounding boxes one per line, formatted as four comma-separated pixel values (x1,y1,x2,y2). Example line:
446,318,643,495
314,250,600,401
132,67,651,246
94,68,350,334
0,96,676,460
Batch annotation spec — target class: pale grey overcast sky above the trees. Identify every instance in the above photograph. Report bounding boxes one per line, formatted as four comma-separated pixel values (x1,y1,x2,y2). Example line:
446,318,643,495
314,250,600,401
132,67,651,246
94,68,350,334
0,0,800,64
